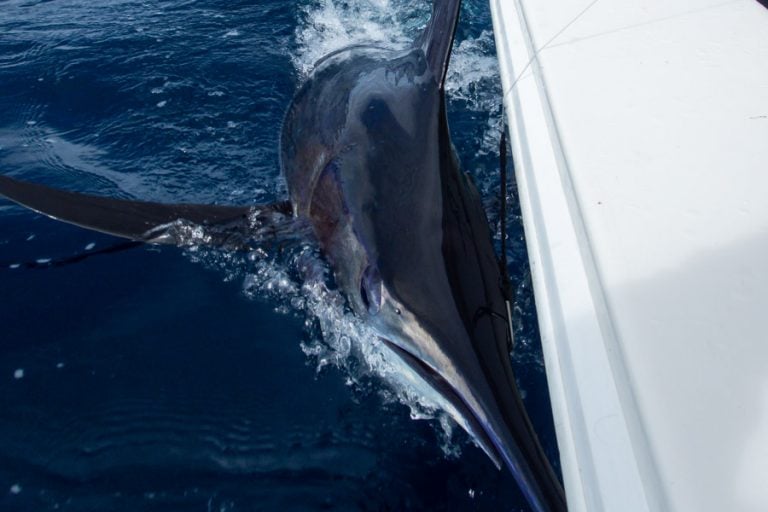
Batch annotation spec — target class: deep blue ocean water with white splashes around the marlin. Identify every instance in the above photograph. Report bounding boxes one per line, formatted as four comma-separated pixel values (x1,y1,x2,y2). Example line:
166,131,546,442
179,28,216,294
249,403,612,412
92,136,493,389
0,0,557,511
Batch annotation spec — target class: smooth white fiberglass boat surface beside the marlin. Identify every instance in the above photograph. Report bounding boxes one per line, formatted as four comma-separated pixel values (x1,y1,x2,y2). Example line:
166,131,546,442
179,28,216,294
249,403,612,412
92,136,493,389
495,0,768,511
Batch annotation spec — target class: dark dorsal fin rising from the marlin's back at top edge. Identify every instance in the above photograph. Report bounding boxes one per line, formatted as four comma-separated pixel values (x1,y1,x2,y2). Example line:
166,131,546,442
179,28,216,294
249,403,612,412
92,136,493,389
420,0,461,89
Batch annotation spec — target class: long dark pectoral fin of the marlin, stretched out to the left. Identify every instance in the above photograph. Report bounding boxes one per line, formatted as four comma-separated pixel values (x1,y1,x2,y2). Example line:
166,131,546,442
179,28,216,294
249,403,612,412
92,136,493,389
0,176,293,249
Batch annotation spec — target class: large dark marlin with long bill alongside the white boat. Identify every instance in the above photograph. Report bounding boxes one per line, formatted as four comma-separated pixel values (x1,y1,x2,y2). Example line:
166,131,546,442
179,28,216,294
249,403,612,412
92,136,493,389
0,0,567,512
